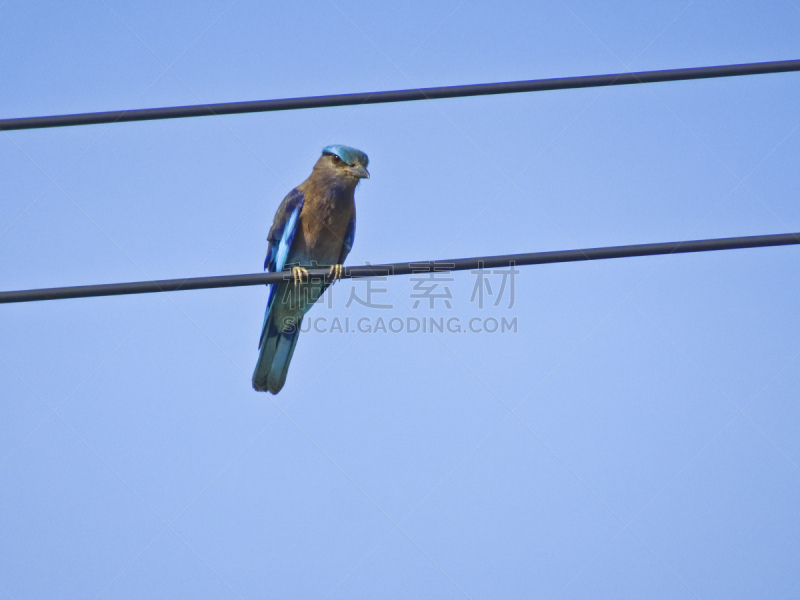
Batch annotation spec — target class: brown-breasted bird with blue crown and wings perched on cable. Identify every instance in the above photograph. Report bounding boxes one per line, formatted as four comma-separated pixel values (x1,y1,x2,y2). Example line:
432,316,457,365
253,144,369,394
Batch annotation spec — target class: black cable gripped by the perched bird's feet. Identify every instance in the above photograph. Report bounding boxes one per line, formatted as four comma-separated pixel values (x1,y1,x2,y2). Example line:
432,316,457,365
0,233,800,304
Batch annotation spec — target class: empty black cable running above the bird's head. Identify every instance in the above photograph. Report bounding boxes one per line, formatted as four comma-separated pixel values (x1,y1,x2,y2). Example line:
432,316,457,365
0,60,800,131
